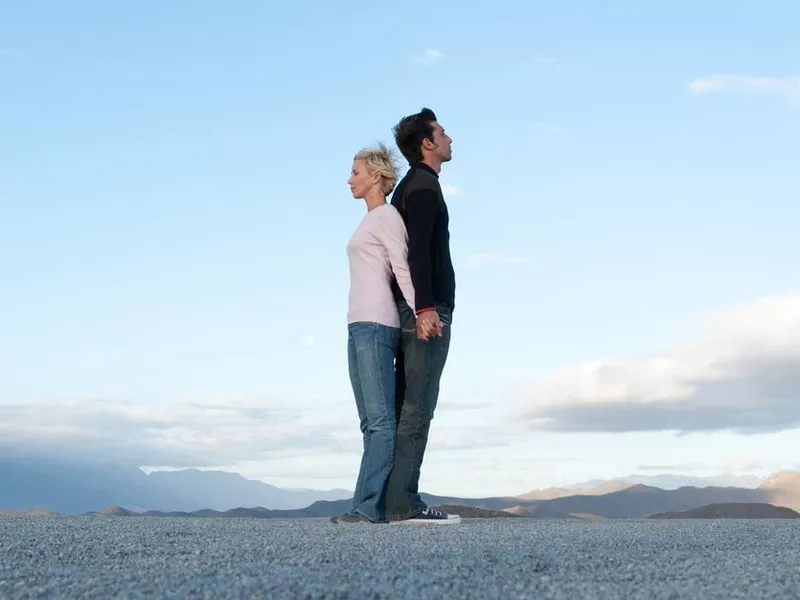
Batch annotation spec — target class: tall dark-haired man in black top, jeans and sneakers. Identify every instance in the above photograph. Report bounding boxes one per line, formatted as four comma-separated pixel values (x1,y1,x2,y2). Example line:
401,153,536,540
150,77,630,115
386,108,460,523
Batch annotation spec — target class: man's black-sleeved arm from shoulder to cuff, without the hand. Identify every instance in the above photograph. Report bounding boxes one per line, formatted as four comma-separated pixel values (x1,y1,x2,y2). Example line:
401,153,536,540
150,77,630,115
406,189,439,315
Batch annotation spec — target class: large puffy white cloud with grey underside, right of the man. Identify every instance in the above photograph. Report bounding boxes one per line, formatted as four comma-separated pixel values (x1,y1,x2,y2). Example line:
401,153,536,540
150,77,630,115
517,293,800,433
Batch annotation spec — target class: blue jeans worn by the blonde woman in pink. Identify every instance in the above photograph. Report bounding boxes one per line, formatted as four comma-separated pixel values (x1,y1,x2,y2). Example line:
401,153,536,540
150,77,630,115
347,322,400,522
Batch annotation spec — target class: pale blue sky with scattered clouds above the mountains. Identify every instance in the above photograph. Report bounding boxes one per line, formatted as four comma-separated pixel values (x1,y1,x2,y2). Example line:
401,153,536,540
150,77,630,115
0,0,800,496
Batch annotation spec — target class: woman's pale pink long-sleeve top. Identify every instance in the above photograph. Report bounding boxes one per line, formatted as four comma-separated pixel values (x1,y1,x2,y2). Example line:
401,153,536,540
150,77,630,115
347,204,414,327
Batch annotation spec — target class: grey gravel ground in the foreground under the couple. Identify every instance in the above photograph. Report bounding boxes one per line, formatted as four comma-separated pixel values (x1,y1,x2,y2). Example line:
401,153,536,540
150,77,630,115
0,517,800,600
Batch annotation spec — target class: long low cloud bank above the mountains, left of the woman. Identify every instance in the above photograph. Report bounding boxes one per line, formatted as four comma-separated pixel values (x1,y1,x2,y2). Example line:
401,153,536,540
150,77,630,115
0,397,360,467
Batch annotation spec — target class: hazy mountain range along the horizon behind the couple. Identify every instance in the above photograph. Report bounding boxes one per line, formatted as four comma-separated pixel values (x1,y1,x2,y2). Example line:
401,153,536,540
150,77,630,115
0,457,800,519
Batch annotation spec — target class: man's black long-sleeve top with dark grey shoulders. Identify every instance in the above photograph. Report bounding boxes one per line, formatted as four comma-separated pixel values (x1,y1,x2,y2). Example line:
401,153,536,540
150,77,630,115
392,163,456,313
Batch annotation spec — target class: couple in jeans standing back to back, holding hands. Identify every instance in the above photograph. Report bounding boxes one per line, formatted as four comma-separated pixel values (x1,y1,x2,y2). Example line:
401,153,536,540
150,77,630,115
332,108,460,524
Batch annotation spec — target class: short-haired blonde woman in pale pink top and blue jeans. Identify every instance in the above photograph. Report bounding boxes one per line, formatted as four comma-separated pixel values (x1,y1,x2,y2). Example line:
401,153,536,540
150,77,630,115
332,144,414,523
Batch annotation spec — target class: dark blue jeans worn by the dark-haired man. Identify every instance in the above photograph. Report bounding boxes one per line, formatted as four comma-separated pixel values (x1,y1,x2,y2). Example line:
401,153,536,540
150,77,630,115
386,301,452,520
